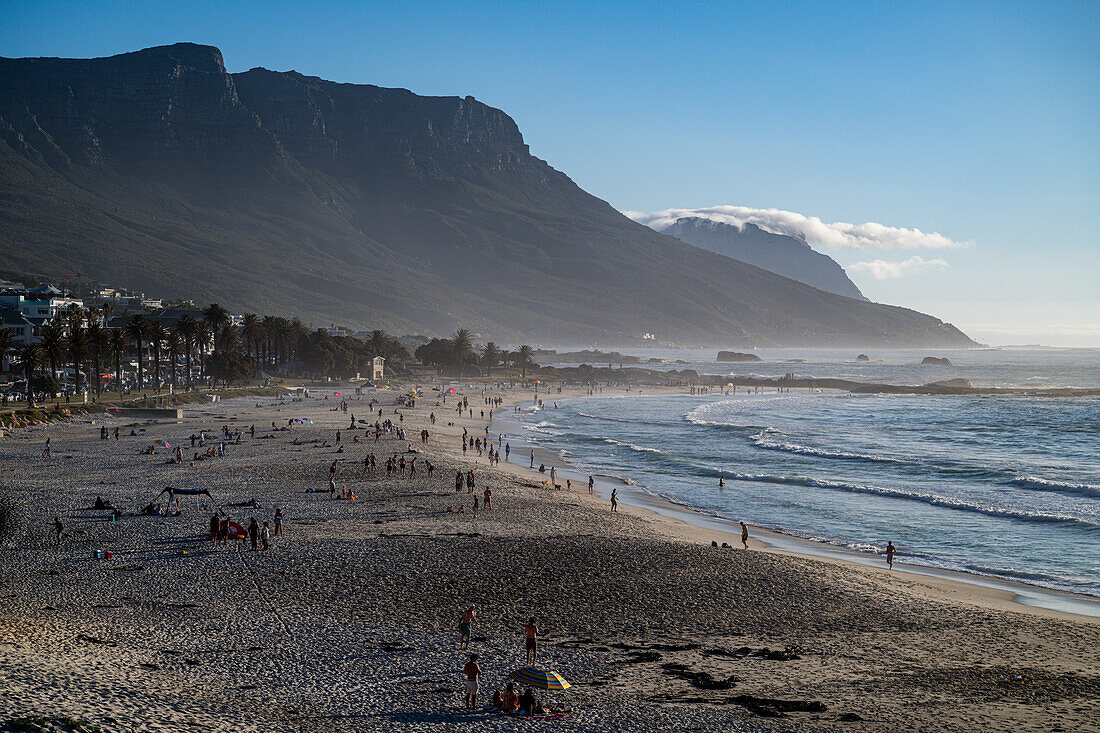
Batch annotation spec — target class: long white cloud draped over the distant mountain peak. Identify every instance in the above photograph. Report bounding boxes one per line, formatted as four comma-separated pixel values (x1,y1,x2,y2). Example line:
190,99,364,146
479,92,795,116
624,206,972,250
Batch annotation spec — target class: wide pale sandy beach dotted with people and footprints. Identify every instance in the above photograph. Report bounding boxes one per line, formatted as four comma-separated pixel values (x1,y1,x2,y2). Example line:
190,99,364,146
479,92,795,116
0,387,1100,731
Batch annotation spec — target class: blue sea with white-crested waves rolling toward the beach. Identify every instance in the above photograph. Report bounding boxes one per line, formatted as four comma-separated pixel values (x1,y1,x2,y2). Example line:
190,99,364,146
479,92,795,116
517,348,1100,597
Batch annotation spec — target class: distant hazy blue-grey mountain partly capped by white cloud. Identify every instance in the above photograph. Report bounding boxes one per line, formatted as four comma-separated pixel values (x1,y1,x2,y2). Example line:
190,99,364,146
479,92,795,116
660,217,867,300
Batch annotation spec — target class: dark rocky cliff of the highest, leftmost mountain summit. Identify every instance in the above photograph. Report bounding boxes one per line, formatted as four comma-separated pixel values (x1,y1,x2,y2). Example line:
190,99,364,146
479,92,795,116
0,44,283,185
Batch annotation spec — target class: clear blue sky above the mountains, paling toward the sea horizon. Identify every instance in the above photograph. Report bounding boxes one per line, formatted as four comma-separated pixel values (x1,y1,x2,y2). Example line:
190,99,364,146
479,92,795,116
0,0,1100,346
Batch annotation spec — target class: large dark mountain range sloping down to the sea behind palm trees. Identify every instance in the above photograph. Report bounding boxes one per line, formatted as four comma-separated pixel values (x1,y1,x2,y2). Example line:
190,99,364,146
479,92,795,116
0,43,972,347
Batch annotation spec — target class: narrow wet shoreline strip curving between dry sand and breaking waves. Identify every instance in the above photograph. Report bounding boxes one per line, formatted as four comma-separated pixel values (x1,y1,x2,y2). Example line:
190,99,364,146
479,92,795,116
493,387,1100,624
